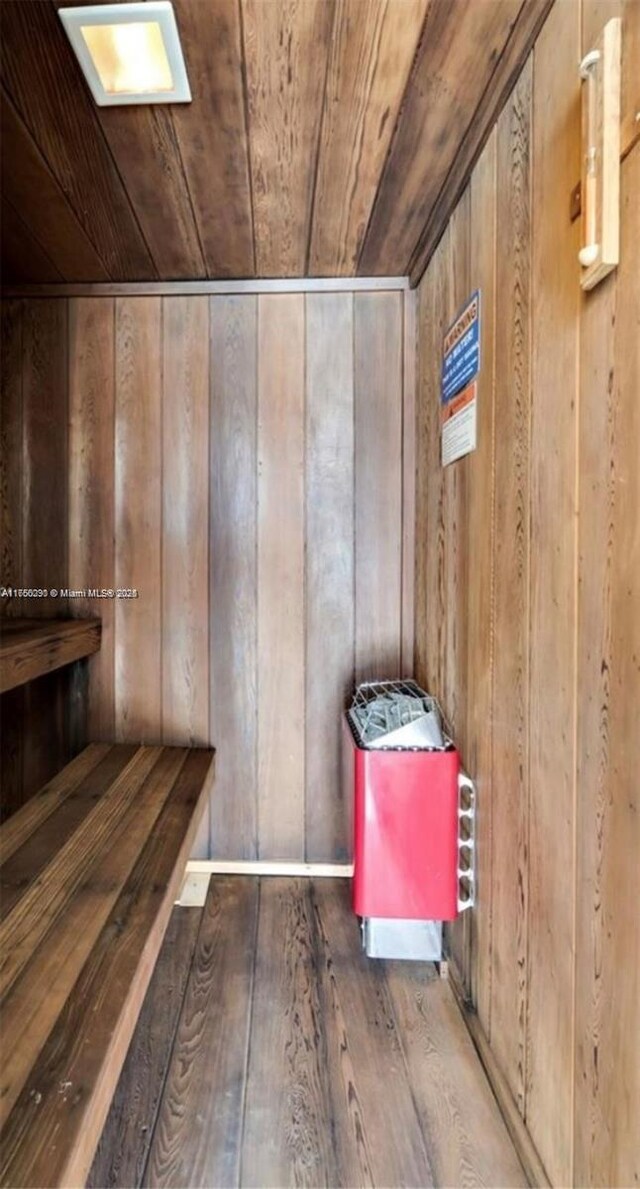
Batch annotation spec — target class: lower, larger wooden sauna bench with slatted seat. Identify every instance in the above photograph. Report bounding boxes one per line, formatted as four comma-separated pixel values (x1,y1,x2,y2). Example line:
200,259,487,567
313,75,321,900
0,743,214,1189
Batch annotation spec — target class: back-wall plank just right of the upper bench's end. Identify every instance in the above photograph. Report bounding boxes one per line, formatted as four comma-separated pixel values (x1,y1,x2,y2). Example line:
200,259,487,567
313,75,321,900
115,297,162,742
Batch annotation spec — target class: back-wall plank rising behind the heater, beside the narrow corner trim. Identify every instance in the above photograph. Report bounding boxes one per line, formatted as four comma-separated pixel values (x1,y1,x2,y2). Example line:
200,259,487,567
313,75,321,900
354,294,402,681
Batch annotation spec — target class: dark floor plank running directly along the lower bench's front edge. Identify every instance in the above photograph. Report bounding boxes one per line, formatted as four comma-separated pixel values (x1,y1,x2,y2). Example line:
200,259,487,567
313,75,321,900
87,907,202,1189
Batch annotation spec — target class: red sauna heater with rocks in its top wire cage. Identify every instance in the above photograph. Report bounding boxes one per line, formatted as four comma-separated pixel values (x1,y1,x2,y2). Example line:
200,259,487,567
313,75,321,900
343,680,475,961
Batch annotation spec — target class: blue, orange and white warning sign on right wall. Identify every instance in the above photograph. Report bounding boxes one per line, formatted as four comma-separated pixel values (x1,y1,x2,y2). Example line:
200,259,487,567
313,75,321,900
440,289,481,466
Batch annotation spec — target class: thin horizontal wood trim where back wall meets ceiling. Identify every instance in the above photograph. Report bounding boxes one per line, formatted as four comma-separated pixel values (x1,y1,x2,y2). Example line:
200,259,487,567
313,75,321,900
2,277,409,297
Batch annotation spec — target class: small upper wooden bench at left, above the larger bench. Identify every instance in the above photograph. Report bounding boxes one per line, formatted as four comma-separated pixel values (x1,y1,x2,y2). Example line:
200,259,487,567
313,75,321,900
0,618,101,693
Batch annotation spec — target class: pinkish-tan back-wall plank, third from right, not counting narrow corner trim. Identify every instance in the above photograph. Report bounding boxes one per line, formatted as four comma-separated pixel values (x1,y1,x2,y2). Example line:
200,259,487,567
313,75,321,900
258,295,305,860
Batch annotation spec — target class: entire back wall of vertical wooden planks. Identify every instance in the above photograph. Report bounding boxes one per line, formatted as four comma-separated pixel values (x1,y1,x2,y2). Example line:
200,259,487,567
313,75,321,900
2,290,413,862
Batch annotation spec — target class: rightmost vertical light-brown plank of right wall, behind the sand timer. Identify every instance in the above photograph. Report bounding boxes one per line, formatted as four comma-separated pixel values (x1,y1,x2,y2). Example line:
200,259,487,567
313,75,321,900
575,0,640,1184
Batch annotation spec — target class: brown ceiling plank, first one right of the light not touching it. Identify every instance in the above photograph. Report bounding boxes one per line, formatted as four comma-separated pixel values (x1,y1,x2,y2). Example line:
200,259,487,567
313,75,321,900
241,0,333,277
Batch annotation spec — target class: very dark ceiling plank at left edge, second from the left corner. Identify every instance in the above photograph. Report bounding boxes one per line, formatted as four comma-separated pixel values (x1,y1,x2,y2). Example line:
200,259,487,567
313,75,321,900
0,94,108,281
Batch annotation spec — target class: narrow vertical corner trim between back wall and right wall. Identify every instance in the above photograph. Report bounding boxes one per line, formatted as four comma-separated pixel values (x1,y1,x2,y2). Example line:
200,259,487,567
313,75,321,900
401,289,418,677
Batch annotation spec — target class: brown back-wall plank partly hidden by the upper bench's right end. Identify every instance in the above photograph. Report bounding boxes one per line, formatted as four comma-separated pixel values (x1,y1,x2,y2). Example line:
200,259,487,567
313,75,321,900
69,297,115,740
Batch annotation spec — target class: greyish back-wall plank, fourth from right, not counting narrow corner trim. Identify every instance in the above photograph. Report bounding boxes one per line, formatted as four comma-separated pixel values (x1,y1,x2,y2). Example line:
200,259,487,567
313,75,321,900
209,296,258,858
